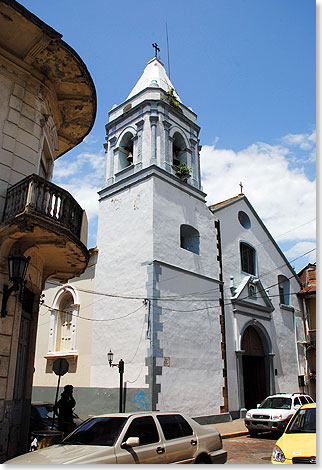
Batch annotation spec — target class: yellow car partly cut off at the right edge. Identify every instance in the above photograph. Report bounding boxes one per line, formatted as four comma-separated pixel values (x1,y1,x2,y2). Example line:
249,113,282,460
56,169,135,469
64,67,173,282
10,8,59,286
271,403,316,464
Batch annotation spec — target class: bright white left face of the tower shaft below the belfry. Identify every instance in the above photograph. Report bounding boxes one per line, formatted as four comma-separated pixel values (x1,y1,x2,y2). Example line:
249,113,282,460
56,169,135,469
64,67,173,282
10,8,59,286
91,180,153,388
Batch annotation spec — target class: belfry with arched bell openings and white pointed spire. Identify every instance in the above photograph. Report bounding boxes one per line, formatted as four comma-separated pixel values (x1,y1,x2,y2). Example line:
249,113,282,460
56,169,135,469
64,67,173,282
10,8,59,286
104,57,201,190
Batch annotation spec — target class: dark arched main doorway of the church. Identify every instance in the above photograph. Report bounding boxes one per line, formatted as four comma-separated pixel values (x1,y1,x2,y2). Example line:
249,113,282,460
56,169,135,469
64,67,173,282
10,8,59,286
241,326,269,410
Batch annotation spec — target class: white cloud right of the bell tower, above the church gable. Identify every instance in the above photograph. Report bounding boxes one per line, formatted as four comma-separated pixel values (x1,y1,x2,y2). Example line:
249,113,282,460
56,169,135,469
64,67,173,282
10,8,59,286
201,138,316,243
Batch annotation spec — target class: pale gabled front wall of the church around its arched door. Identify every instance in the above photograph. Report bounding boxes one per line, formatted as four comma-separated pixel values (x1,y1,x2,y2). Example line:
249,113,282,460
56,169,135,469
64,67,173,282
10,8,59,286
214,199,304,410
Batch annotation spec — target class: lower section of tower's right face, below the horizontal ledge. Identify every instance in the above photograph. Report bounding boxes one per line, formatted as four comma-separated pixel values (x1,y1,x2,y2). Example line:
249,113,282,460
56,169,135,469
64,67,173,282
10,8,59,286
157,265,224,416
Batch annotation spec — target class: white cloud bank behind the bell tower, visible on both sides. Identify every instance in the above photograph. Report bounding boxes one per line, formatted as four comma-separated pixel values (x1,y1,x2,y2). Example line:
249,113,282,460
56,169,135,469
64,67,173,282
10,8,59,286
54,132,316,262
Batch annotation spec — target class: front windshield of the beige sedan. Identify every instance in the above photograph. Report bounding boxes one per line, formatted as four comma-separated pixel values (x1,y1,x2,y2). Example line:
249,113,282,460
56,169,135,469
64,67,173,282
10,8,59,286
61,417,127,446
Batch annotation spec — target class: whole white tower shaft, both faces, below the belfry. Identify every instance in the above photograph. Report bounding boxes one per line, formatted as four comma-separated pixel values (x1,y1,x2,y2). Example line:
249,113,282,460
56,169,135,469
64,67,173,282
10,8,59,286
91,174,223,416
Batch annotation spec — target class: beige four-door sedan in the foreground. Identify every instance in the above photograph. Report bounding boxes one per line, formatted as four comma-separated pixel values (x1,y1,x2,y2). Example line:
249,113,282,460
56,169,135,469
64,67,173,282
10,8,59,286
5,411,227,465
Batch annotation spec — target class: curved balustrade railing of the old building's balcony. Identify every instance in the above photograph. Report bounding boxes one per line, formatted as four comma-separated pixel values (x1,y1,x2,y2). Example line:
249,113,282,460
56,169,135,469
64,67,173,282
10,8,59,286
2,175,83,238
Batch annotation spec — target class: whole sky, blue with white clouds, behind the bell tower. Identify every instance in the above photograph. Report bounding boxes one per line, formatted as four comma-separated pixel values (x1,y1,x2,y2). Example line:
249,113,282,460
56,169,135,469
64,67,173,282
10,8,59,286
21,0,316,269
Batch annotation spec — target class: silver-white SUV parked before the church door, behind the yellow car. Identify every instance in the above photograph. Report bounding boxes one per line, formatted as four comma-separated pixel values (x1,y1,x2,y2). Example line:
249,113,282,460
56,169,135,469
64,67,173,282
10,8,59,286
245,393,314,436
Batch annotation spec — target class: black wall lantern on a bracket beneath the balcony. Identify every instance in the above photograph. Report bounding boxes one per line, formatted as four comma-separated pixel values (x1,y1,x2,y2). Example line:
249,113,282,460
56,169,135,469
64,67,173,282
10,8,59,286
1,255,30,317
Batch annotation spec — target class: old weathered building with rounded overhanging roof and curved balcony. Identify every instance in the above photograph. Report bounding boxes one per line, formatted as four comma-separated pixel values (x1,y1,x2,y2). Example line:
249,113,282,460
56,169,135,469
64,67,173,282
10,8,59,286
0,0,96,461
